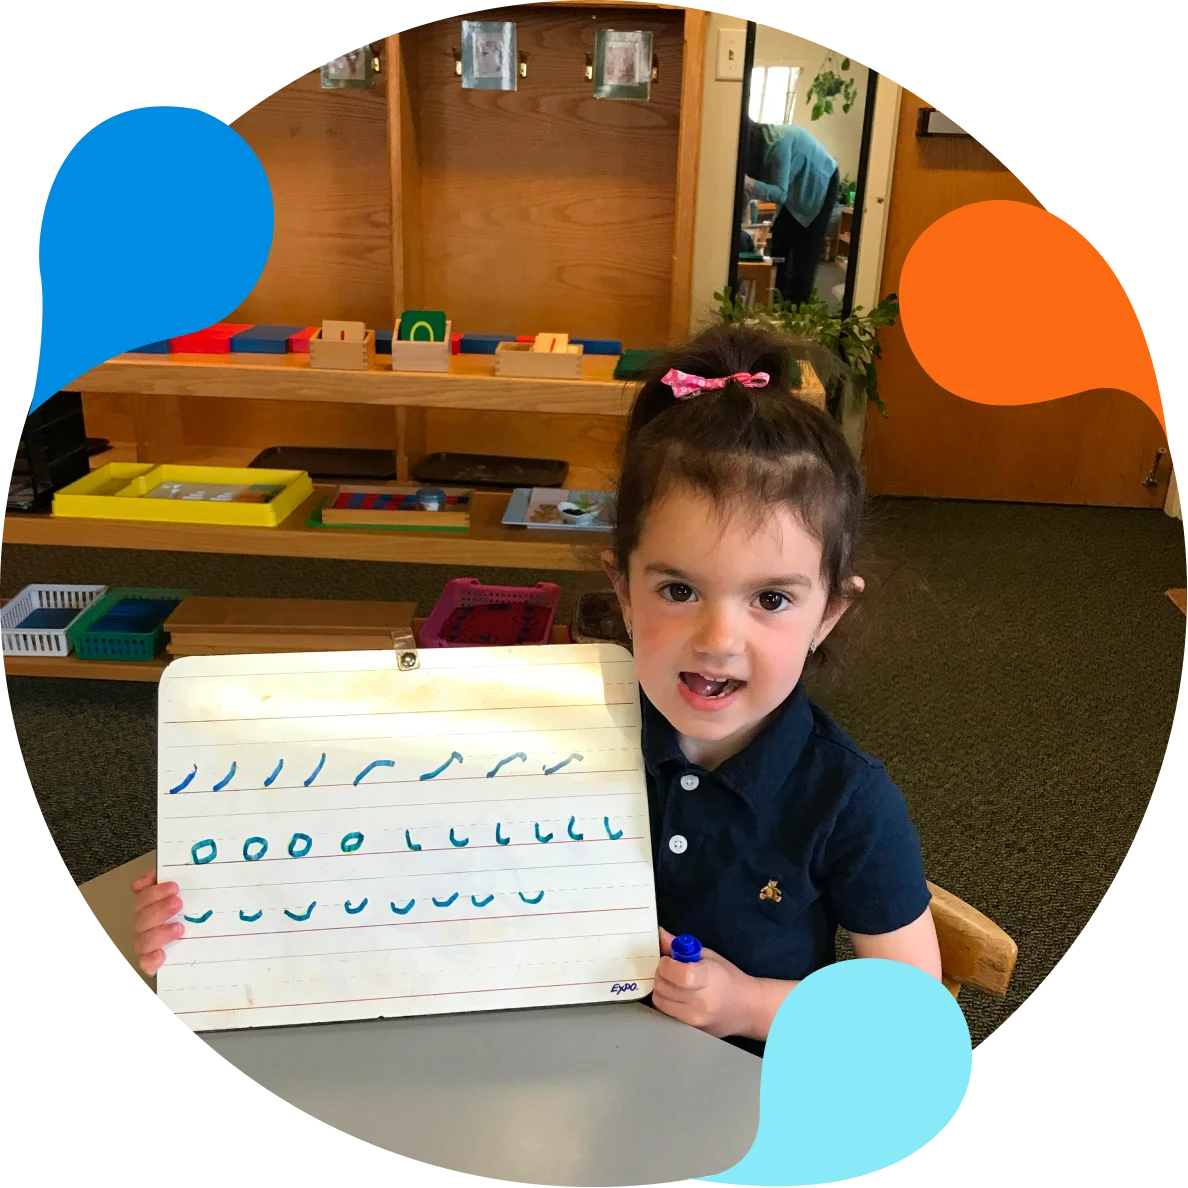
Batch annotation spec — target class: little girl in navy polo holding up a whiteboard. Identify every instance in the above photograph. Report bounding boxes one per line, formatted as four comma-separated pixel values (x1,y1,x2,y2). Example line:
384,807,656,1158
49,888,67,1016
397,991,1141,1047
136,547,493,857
133,327,941,1054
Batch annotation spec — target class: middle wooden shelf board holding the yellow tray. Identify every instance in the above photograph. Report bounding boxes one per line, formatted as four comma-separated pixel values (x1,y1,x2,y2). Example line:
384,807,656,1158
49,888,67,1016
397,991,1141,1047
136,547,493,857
0,487,609,571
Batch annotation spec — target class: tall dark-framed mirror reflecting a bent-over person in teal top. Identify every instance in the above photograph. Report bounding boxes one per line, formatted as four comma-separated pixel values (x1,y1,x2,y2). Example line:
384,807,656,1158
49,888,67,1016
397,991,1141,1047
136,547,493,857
731,31,873,317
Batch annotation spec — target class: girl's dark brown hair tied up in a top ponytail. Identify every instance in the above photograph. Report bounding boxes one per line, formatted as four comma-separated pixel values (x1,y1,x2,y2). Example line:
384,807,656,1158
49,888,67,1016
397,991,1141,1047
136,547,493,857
613,323,865,674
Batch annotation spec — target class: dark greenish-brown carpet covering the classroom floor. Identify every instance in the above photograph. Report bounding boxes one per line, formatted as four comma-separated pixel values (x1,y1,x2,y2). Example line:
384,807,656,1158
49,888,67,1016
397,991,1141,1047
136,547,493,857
0,500,1188,1043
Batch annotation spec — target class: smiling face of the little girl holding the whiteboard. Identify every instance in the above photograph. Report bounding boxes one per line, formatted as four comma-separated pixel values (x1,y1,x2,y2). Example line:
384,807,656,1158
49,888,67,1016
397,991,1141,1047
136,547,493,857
612,489,860,766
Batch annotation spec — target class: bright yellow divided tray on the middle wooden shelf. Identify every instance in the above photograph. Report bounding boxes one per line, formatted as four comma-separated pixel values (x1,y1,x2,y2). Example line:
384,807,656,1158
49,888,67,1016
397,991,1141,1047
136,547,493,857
53,462,314,527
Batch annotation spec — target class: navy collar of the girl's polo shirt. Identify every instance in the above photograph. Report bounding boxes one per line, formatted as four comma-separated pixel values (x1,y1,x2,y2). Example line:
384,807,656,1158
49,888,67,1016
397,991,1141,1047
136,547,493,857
639,683,813,808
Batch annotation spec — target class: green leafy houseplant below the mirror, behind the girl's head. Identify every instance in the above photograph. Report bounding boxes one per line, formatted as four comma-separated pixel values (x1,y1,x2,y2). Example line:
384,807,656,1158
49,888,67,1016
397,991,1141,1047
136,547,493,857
714,290,899,419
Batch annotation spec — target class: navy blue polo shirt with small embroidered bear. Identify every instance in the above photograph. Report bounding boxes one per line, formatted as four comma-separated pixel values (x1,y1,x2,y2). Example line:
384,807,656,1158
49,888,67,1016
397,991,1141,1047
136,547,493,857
640,683,931,1050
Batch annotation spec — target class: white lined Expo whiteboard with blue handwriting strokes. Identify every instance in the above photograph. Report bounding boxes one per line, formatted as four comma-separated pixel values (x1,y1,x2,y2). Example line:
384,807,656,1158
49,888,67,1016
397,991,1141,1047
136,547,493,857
157,644,659,1031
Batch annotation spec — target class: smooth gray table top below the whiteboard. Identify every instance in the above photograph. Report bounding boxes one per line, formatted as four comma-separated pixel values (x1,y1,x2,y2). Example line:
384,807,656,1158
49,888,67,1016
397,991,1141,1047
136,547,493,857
198,1003,762,1188
